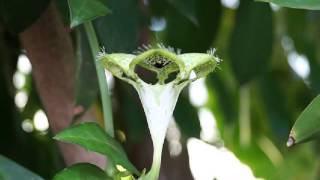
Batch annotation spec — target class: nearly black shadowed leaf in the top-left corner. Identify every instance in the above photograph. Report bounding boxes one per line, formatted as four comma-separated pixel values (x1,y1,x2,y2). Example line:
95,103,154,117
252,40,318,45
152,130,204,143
0,0,50,33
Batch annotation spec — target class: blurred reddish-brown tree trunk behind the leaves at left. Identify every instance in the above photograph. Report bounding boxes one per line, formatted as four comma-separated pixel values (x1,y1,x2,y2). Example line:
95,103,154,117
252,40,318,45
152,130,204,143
20,3,106,167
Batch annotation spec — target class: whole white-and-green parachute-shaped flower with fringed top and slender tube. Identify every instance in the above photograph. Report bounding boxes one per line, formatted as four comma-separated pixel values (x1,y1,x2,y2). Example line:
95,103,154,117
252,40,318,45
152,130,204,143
97,45,220,180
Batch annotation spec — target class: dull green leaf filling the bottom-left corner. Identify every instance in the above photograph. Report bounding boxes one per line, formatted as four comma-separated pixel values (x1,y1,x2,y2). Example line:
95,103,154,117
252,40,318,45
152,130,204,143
0,155,43,180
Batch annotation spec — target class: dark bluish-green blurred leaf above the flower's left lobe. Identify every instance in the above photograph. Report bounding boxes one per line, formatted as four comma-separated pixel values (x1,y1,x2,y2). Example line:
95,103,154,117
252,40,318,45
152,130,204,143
94,0,141,53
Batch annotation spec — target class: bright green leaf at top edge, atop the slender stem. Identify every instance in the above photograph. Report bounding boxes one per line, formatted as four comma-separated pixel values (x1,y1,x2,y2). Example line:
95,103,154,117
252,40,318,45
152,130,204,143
68,0,111,27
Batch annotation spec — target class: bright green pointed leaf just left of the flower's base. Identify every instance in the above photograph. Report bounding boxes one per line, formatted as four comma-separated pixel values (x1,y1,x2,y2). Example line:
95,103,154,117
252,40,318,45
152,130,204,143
54,122,139,174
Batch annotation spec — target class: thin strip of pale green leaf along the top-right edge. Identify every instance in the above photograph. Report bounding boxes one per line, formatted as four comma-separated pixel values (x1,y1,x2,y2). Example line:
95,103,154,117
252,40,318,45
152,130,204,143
257,0,320,10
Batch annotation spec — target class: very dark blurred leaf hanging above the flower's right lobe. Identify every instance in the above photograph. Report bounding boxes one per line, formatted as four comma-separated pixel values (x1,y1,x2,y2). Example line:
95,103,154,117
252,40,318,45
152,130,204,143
164,0,222,52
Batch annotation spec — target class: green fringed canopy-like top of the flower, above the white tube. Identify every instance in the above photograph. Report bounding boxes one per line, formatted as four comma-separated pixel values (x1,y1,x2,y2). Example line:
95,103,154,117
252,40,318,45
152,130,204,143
97,46,220,84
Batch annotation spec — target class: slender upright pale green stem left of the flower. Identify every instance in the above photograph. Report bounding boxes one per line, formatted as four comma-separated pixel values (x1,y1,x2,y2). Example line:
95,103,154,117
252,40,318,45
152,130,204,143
84,22,114,137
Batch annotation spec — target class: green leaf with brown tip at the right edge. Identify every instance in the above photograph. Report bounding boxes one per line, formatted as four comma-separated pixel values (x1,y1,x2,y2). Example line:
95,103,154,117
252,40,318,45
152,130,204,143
287,95,320,147
